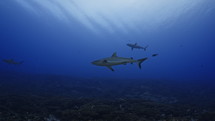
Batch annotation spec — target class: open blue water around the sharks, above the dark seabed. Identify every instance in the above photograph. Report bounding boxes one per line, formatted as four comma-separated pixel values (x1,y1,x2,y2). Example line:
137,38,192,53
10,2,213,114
0,0,215,120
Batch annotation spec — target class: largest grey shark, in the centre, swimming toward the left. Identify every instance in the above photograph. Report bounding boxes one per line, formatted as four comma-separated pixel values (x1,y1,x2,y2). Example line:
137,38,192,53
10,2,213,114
92,52,147,71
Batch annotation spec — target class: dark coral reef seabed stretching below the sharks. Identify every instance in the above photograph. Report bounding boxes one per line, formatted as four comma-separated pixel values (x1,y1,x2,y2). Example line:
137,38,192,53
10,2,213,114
0,73,215,121
